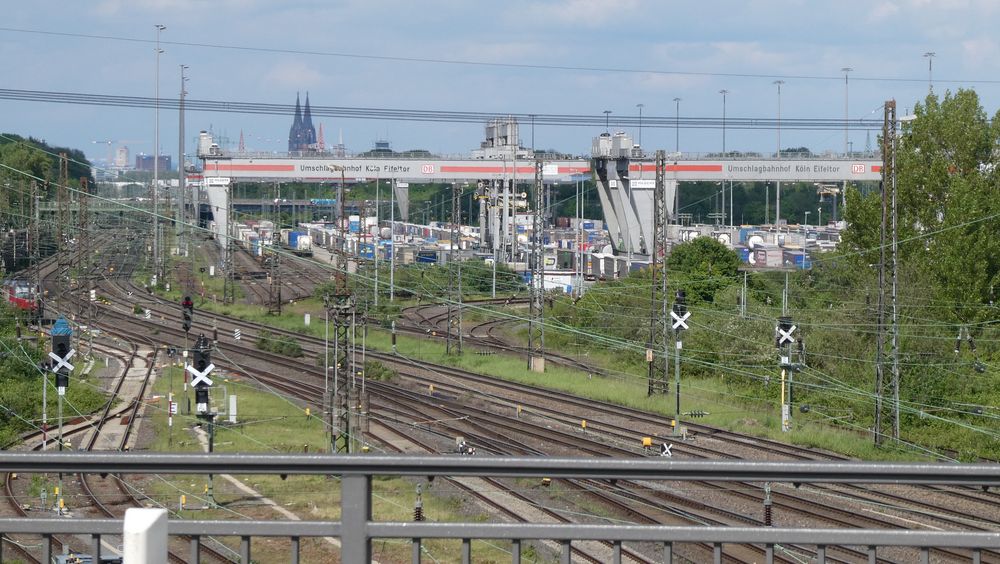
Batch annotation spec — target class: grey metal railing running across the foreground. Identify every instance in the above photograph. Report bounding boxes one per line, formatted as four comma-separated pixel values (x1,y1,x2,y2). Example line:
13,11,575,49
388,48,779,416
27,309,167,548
0,452,1000,563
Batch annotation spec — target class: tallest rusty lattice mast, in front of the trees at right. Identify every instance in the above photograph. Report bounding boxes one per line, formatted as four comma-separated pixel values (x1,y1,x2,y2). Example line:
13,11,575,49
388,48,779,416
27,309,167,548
874,100,899,445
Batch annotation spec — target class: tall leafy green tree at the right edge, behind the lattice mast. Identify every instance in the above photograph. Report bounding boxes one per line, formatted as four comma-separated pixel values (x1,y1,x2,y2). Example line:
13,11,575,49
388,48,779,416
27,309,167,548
844,90,1000,323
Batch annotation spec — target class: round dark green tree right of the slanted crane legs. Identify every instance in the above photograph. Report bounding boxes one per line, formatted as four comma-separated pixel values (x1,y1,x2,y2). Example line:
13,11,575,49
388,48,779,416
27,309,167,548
667,237,742,302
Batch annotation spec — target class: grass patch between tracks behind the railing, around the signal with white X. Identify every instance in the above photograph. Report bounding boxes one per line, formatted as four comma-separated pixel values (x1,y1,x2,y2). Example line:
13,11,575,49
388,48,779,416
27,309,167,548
144,367,527,562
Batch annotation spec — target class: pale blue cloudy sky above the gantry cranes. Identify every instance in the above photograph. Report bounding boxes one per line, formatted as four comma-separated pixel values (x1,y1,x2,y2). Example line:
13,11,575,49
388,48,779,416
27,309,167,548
0,0,1000,165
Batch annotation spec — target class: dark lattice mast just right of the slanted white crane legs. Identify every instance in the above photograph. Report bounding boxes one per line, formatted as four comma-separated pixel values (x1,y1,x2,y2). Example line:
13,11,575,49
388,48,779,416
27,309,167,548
648,151,670,396
